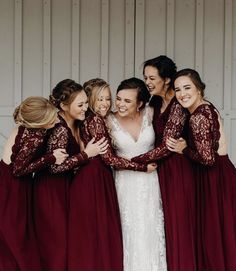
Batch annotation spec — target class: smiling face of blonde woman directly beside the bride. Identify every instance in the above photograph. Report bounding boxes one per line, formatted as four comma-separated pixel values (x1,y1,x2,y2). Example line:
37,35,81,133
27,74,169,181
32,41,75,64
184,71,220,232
93,86,111,117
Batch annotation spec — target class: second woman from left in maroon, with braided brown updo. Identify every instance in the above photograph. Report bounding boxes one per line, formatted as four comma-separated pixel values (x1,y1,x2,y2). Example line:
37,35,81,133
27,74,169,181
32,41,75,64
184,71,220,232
34,79,106,271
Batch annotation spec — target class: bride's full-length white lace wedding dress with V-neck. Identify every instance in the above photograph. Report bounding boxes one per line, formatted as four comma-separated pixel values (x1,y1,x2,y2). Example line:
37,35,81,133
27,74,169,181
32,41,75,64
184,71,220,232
108,107,167,271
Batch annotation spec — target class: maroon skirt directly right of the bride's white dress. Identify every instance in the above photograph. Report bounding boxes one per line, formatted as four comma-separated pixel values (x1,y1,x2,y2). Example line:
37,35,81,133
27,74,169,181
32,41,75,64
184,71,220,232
158,154,197,271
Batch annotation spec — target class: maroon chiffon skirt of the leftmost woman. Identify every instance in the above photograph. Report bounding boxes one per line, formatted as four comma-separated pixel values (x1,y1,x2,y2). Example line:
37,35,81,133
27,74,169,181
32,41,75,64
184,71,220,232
0,160,42,271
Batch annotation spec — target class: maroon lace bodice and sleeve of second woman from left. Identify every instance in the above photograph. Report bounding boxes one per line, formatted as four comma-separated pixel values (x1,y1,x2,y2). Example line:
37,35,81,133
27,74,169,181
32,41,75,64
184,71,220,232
48,116,88,173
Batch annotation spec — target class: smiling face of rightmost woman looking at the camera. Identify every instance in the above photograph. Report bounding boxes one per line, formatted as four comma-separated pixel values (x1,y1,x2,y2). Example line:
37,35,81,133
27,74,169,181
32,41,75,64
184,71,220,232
174,76,203,113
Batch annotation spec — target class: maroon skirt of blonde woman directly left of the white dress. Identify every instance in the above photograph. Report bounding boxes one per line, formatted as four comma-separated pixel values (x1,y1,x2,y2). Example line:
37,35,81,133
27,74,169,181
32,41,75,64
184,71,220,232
68,157,123,271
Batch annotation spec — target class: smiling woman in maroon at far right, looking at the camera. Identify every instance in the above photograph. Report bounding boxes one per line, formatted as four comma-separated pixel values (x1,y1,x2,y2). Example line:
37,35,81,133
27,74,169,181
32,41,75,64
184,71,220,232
167,69,236,271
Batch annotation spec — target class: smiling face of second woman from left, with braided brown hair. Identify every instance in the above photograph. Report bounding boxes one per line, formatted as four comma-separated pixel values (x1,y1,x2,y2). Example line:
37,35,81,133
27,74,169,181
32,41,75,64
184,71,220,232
62,90,88,121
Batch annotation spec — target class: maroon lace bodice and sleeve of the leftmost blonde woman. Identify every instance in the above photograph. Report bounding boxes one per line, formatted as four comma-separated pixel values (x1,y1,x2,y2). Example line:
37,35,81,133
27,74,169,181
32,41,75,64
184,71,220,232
11,126,56,177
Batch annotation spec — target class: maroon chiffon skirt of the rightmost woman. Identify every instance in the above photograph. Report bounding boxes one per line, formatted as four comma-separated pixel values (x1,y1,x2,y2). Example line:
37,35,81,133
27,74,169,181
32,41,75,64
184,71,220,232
195,155,236,271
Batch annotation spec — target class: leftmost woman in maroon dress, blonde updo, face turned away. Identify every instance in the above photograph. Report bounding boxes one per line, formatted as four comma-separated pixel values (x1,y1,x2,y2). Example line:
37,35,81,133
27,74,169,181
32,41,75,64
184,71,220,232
0,97,66,271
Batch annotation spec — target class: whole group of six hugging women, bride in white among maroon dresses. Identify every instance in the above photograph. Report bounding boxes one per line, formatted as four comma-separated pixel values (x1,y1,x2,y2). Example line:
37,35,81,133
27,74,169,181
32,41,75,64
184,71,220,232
0,55,236,271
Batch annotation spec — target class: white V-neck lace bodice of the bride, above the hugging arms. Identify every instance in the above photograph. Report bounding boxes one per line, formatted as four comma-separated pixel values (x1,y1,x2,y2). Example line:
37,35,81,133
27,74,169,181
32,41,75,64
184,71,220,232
108,107,155,159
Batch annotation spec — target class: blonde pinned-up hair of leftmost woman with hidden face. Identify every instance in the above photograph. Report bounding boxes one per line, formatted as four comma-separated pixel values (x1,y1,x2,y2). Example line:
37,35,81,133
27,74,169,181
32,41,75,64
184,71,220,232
13,96,57,128
